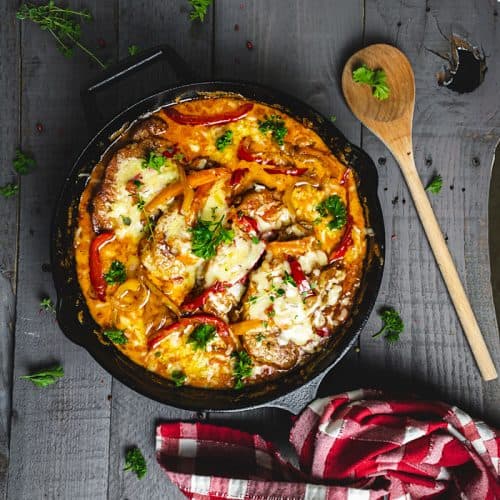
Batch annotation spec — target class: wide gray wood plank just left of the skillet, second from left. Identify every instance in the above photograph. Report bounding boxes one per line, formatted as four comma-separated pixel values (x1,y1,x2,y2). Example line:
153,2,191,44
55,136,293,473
6,1,115,499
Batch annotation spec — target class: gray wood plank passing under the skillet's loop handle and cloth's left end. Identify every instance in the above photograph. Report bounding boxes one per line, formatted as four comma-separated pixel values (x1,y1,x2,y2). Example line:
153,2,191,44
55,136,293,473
108,0,213,500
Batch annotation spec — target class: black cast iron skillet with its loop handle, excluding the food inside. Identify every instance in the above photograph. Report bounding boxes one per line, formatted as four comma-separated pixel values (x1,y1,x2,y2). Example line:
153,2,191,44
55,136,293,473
51,46,384,413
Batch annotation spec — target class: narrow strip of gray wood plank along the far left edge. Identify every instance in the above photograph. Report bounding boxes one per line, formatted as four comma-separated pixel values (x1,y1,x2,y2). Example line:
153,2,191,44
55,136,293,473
0,1,20,499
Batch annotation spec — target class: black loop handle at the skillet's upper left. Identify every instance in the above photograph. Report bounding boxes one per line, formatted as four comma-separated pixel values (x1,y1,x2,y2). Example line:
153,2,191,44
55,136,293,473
80,45,195,132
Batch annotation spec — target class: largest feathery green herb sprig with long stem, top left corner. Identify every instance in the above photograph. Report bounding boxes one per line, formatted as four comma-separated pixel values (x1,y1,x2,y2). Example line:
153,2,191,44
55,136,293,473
16,0,106,68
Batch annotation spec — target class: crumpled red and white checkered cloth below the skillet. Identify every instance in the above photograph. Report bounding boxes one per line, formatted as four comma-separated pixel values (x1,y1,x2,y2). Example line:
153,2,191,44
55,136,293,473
156,390,500,500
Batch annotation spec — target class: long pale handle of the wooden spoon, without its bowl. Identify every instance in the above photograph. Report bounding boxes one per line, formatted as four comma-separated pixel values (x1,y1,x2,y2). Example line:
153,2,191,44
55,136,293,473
388,141,498,380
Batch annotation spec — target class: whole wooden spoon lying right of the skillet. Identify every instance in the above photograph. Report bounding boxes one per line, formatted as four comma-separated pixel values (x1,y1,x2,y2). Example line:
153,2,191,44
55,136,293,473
342,44,497,380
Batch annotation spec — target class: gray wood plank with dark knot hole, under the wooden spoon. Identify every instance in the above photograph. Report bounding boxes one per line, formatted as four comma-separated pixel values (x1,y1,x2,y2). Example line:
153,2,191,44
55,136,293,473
361,0,500,425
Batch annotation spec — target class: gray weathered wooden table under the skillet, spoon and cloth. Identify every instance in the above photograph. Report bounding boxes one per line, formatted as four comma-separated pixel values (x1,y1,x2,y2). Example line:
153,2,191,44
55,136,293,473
0,0,500,500
